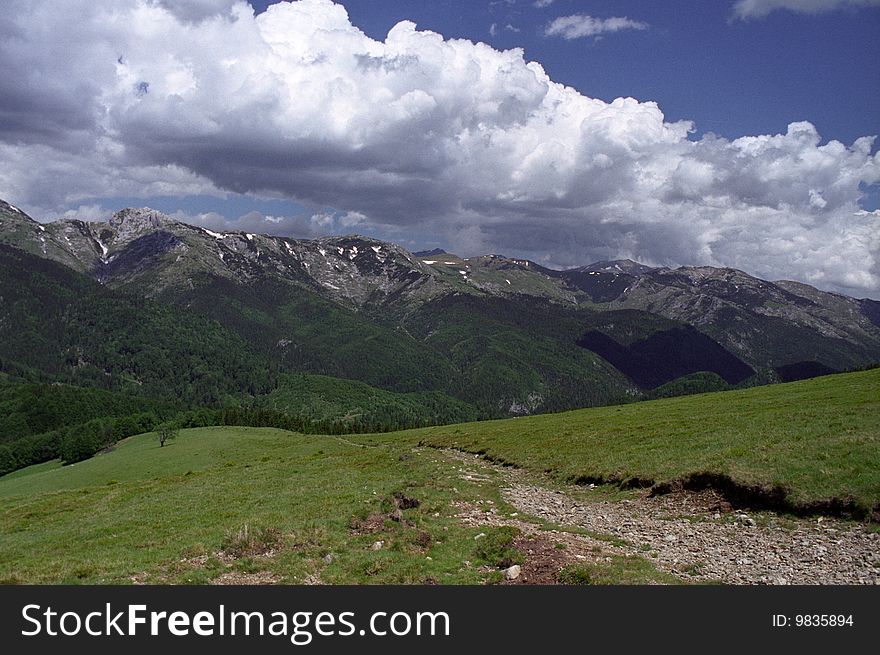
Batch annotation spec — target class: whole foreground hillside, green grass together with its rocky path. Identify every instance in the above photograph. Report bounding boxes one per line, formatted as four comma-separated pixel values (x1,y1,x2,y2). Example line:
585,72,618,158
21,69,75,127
0,370,880,583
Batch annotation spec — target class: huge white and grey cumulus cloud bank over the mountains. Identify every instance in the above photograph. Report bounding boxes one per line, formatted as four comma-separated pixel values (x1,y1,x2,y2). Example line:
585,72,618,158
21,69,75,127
0,0,880,297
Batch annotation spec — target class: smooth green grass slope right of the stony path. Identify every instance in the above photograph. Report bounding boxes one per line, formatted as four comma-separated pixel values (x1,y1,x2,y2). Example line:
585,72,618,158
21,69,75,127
410,369,880,509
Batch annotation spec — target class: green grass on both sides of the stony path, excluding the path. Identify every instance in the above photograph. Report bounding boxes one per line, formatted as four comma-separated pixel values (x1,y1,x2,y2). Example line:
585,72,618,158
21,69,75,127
0,370,880,584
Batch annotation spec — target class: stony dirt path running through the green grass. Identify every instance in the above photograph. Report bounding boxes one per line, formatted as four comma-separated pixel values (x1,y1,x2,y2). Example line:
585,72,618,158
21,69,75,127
444,451,880,584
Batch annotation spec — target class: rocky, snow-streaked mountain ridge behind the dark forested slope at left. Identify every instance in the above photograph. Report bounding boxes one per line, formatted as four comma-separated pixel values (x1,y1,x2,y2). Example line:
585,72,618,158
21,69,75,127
0,197,880,416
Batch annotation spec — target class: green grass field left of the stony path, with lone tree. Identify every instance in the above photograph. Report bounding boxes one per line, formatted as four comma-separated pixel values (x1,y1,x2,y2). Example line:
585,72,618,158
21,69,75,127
0,428,524,584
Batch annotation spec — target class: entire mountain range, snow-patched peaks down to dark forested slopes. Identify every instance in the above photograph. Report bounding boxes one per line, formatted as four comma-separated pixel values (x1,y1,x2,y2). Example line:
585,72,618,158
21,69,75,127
0,201,880,424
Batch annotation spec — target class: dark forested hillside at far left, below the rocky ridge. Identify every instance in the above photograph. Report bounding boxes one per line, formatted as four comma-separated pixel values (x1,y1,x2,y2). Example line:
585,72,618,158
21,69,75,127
0,244,273,404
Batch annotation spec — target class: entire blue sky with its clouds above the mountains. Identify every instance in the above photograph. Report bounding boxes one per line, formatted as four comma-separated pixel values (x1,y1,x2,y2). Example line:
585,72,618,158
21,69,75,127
0,0,880,298
